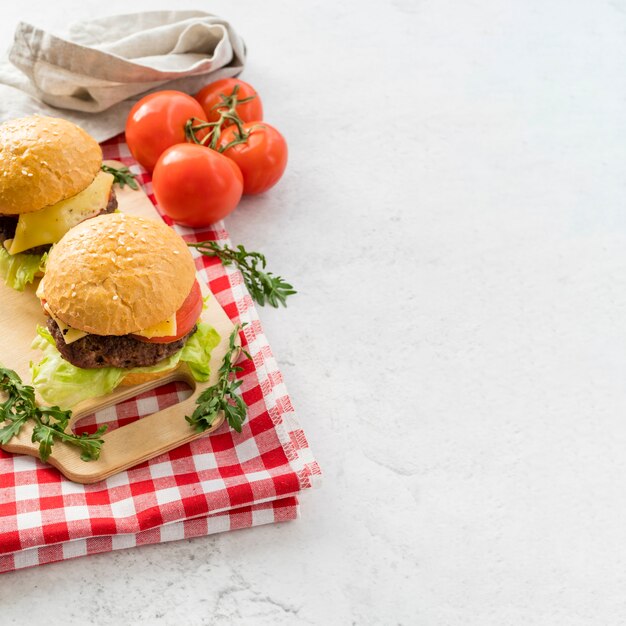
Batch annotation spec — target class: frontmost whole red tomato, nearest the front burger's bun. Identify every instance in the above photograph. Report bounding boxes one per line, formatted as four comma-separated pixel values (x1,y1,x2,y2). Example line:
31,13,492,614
152,143,243,226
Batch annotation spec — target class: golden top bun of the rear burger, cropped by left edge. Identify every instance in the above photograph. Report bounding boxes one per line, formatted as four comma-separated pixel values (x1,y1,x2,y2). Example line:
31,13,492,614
0,115,102,215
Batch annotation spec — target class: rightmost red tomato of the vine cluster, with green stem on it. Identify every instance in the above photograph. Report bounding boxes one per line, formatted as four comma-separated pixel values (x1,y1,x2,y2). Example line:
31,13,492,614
220,122,287,194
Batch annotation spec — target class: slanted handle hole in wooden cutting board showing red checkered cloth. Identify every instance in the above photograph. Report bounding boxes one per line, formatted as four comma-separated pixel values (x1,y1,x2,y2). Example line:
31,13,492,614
72,380,194,434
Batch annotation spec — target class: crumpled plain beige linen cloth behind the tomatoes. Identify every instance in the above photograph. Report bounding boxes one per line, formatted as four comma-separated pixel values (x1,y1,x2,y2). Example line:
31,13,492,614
0,11,246,141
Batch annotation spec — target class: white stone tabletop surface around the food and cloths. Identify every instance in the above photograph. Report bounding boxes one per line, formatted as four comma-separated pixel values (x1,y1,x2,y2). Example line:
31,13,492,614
0,0,626,626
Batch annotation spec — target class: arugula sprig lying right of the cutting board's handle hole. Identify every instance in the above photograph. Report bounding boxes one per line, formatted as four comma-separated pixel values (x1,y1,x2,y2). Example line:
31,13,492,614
185,324,252,433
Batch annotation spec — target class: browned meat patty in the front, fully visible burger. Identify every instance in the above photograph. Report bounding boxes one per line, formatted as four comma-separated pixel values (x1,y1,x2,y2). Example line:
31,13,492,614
48,317,197,369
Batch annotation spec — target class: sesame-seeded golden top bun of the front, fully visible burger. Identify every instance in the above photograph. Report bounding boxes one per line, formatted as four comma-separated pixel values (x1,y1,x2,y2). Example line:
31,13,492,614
41,213,195,335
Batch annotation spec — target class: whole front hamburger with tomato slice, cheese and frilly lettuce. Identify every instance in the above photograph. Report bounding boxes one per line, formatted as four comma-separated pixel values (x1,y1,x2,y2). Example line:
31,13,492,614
31,213,220,408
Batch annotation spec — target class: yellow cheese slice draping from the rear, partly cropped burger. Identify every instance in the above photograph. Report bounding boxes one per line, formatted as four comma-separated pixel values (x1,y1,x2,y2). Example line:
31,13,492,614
8,172,113,254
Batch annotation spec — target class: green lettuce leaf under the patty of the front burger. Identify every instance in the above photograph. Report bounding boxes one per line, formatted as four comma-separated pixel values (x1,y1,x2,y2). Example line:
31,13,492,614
30,322,220,409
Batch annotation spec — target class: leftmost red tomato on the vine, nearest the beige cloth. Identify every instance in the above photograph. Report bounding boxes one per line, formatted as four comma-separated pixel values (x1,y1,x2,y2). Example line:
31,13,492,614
126,91,205,170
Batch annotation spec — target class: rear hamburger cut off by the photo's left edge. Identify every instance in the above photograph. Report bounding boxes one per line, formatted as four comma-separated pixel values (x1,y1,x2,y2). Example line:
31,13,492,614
0,115,117,291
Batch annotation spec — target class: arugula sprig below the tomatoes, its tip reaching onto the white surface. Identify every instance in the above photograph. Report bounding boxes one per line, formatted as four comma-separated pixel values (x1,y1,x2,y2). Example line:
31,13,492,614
187,241,298,308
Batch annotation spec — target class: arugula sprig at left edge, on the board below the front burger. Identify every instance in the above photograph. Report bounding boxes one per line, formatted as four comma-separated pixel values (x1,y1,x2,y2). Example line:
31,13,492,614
0,367,107,461
